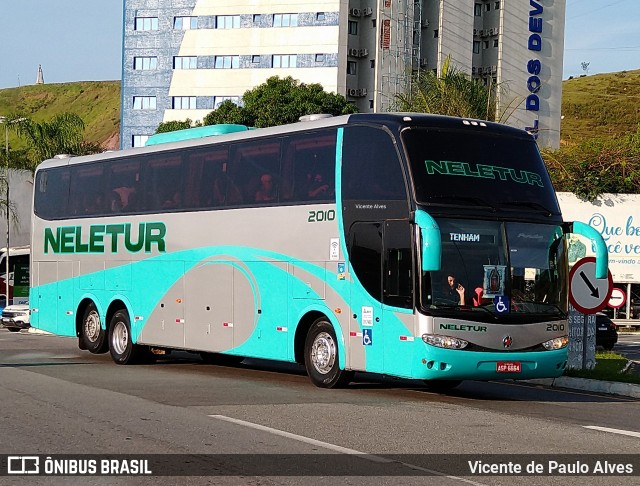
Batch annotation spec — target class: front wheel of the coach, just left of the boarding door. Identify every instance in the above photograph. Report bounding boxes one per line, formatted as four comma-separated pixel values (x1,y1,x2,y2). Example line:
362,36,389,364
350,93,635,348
304,318,353,388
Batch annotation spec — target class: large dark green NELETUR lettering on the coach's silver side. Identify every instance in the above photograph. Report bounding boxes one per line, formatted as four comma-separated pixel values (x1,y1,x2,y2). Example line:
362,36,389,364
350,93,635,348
44,223,167,254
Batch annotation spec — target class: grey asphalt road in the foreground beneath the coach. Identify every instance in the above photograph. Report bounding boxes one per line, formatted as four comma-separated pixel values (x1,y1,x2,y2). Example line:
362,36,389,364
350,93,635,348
0,329,640,485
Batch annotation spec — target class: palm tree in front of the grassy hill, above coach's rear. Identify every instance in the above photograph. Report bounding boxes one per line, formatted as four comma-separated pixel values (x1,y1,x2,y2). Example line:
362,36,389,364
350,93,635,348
15,113,102,172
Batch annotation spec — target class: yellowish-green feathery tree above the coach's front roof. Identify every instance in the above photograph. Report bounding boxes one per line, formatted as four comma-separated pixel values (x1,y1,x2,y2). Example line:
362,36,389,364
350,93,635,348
394,57,498,121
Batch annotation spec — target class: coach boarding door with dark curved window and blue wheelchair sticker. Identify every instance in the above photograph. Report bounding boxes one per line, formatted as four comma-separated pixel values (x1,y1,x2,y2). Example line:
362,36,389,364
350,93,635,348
348,222,384,373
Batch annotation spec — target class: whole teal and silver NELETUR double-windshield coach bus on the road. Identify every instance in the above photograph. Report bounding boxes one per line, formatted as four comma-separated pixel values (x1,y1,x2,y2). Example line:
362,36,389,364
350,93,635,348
30,114,607,387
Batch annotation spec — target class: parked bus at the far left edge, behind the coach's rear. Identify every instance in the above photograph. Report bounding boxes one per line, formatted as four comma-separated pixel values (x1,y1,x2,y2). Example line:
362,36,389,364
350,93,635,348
0,246,31,309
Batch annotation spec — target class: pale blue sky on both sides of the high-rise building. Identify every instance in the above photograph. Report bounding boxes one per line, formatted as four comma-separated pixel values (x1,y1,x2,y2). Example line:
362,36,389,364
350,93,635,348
0,0,640,89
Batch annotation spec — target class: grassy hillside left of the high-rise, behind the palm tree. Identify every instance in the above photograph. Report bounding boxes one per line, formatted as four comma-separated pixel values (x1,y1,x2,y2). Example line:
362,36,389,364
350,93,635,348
0,81,120,149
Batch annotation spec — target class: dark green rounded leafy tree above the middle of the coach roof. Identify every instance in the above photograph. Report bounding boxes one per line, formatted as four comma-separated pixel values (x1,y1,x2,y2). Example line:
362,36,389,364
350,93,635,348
203,76,358,128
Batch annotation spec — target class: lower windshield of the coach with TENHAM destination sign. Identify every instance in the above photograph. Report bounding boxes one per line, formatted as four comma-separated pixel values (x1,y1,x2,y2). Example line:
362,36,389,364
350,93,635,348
422,218,567,322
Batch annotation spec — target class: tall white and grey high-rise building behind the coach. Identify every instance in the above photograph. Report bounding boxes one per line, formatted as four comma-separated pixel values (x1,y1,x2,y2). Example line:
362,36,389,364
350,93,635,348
121,0,566,148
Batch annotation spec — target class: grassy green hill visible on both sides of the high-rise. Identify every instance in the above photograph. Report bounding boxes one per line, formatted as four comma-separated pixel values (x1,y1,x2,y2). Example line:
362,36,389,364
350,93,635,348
0,70,640,149
